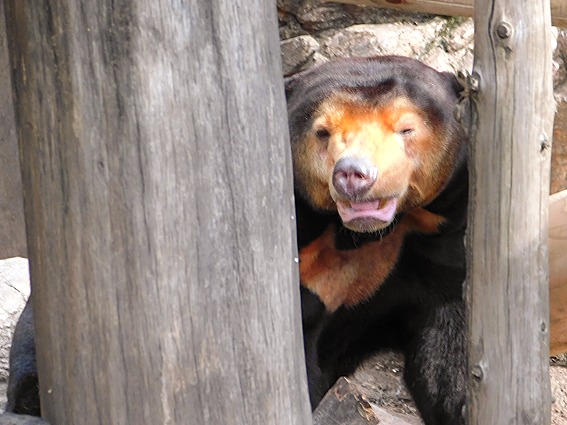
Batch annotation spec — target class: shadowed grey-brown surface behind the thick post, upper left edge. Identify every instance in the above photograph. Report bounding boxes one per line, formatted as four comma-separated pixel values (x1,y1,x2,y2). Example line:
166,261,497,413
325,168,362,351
0,3,27,259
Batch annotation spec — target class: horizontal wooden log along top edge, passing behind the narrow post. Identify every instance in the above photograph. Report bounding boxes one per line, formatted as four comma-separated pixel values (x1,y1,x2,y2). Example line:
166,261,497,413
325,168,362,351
324,0,567,27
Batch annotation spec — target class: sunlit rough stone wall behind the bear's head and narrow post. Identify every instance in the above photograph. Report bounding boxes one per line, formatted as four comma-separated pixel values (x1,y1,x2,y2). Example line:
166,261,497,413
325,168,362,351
277,0,567,193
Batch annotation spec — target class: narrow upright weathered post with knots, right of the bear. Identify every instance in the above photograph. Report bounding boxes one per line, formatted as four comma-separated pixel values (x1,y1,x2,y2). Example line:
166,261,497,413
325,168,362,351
467,0,554,425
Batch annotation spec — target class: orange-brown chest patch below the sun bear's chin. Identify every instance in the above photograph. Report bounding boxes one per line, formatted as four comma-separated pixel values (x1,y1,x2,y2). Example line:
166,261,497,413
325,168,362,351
299,208,444,312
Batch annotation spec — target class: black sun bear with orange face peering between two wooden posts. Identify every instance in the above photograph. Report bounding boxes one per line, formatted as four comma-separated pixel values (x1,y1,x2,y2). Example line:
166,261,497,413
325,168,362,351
286,56,468,425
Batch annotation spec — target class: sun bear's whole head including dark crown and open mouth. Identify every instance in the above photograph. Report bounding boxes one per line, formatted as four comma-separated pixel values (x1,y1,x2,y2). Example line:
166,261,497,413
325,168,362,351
286,57,463,232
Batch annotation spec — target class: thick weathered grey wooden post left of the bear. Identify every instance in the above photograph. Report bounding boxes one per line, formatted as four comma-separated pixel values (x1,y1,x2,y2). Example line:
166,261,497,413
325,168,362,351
5,0,311,425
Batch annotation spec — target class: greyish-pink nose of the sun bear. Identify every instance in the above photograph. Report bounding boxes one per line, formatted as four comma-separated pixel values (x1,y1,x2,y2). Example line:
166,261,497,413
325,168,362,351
333,157,378,198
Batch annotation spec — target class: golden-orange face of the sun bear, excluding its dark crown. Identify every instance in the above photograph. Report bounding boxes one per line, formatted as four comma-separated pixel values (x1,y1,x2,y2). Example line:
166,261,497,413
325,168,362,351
294,93,453,232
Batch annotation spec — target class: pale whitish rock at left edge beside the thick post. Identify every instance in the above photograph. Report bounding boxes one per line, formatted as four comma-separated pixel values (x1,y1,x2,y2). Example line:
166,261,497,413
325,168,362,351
0,257,30,411
